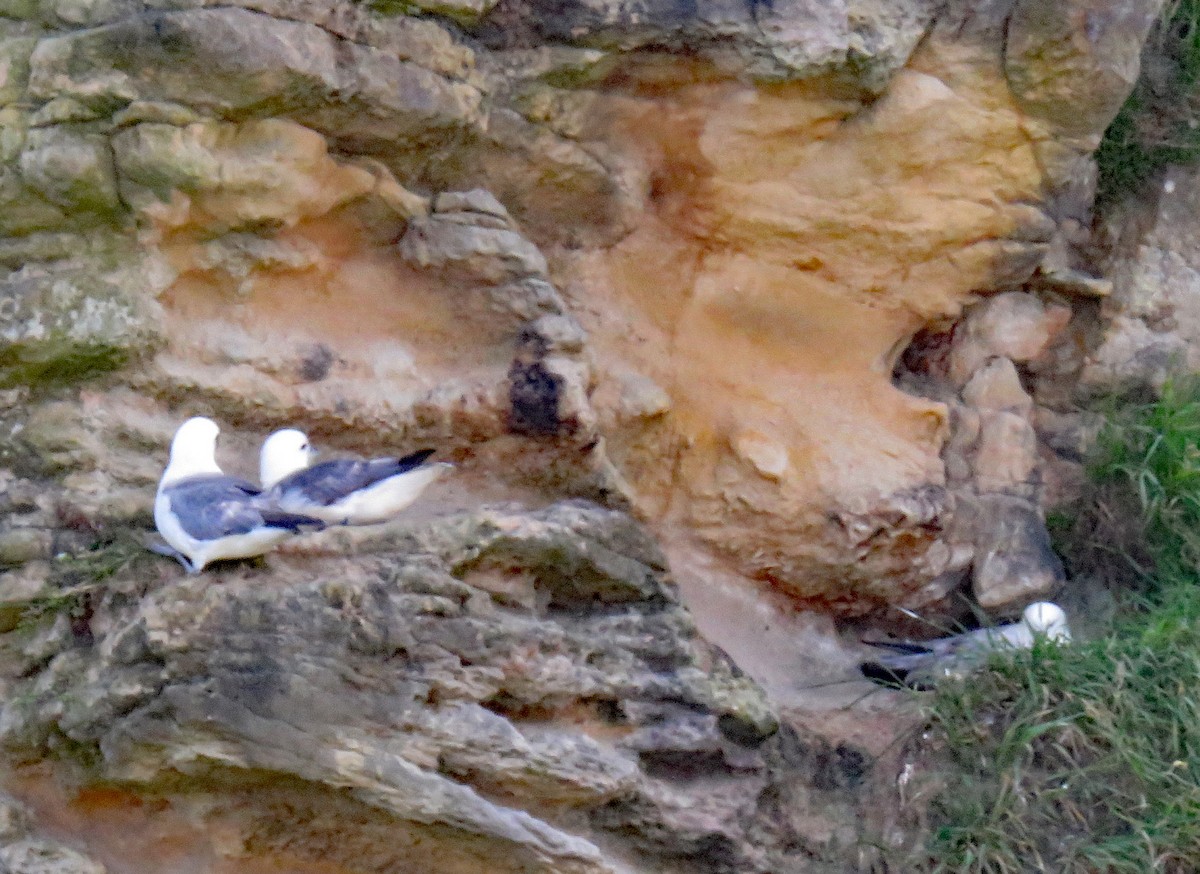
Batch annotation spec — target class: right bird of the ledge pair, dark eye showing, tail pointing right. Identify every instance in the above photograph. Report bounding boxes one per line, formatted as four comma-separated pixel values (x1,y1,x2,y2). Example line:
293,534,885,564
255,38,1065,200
259,427,452,525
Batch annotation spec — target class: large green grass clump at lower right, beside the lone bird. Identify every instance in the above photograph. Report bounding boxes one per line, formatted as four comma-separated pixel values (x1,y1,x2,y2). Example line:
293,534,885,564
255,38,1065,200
905,379,1200,874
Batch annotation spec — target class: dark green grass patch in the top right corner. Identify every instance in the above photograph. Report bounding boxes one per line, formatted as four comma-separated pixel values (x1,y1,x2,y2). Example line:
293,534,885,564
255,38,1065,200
1096,0,1200,205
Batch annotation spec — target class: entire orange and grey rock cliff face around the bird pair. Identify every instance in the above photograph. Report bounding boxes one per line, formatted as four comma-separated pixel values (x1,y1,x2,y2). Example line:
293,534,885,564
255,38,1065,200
0,0,1171,874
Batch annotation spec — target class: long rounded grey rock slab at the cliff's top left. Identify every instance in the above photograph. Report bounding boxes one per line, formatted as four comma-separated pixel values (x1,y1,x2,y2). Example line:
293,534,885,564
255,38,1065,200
29,8,479,139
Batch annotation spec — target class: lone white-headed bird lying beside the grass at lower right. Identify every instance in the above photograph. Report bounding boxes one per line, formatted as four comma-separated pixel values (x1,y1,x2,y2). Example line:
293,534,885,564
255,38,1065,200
859,601,1070,689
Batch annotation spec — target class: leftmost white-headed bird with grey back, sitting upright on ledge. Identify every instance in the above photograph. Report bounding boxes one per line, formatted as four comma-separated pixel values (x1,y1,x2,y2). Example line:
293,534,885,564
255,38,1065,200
152,417,325,574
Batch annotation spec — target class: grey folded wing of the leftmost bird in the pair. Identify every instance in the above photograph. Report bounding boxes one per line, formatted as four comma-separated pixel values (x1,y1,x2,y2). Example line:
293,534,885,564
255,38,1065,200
166,475,324,540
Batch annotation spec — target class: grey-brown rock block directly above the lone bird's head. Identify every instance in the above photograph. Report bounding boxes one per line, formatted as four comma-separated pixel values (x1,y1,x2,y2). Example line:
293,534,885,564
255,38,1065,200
971,495,1064,611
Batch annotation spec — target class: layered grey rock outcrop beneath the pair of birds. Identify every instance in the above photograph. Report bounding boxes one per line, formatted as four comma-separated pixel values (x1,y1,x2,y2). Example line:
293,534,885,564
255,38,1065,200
0,503,878,873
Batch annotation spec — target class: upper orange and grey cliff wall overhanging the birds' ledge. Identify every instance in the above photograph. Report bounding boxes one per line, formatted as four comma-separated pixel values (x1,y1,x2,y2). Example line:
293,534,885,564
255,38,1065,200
0,0,1157,612
